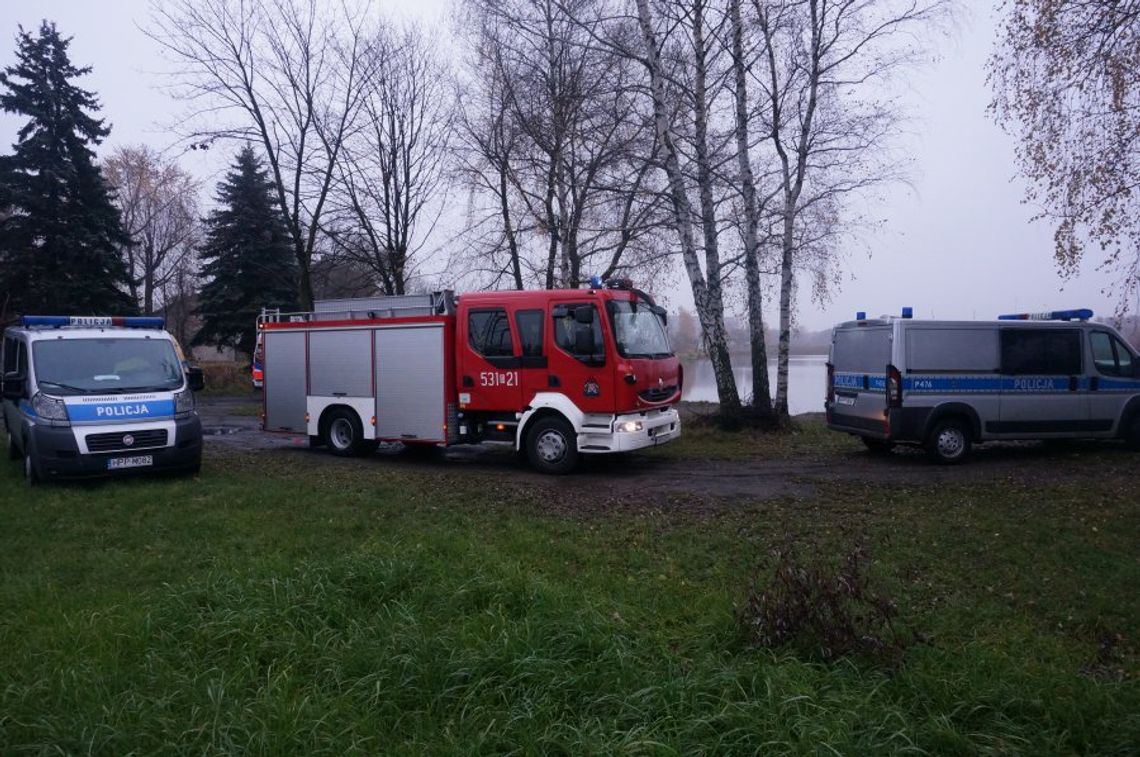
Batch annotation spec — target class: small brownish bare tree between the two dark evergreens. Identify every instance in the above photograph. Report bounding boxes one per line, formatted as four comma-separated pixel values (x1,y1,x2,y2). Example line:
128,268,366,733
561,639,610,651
104,145,198,314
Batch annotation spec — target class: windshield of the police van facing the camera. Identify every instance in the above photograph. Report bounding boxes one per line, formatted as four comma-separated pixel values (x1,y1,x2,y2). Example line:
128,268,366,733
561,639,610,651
32,337,182,394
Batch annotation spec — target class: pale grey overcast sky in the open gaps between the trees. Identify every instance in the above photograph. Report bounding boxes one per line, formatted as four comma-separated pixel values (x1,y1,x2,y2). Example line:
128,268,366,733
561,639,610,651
0,0,1114,329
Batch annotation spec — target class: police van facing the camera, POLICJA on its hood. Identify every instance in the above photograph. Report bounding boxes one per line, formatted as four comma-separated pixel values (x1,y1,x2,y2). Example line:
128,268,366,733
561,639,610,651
2,316,203,483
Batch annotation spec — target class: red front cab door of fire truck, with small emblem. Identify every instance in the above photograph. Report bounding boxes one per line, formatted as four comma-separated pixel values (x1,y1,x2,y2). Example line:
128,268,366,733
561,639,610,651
546,300,617,413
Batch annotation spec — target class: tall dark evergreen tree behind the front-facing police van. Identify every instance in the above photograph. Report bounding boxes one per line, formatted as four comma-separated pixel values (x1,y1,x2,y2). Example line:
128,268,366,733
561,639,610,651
0,22,135,315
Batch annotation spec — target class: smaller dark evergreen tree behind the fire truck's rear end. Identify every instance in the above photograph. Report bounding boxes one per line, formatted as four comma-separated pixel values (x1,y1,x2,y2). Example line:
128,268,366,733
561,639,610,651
194,147,296,355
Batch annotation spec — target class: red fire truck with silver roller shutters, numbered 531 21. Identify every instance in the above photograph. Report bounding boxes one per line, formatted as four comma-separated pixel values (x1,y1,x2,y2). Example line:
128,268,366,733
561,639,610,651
258,280,683,473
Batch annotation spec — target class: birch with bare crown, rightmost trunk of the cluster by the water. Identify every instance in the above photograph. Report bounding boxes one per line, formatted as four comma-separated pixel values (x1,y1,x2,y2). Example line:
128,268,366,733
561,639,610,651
752,0,951,415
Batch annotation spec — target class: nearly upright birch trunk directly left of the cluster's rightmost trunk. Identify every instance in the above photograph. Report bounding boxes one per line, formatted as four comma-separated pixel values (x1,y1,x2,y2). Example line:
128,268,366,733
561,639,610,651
728,0,772,415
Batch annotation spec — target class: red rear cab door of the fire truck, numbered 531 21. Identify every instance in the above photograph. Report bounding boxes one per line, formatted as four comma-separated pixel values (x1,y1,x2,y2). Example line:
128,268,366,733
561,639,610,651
456,304,522,412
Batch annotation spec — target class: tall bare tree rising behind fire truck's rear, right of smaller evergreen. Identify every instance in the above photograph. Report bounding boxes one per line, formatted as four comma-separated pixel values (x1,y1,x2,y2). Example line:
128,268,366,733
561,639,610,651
149,0,375,308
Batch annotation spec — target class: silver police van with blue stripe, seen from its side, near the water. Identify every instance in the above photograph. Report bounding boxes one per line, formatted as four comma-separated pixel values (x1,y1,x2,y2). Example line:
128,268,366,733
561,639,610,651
825,308,1140,463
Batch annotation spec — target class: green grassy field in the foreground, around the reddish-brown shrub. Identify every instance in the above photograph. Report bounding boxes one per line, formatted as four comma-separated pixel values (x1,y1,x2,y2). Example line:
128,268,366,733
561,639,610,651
0,424,1140,755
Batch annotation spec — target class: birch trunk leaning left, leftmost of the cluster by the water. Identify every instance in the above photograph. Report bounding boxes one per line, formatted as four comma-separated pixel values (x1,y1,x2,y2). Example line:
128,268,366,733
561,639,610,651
637,0,740,416
